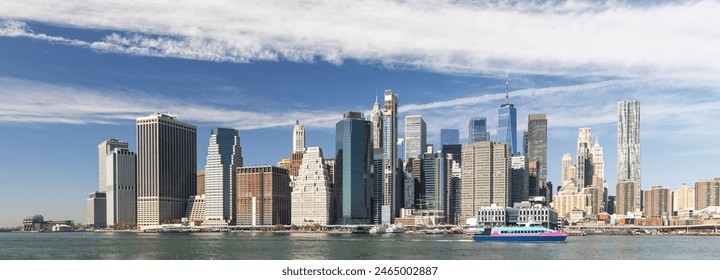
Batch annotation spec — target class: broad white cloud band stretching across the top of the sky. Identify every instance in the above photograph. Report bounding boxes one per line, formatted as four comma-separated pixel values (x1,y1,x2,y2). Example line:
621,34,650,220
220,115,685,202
0,0,720,80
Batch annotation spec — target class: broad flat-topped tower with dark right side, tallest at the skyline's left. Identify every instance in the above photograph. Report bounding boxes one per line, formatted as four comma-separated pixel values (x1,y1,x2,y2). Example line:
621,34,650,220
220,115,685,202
137,113,197,227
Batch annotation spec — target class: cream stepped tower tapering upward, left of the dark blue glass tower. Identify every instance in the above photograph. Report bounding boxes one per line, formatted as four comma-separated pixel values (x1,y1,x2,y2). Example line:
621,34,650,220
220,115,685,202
291,147,333,226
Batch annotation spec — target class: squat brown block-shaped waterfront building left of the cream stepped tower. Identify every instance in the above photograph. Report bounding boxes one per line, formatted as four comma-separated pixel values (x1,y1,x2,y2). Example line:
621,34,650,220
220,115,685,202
236,165,291,226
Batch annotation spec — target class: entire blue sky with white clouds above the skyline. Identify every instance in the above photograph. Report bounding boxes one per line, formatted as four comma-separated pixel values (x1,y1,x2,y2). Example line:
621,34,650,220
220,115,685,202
0,0,720,226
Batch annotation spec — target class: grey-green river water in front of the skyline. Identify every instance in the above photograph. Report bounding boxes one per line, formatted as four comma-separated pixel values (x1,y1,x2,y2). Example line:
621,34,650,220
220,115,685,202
0,232,720,260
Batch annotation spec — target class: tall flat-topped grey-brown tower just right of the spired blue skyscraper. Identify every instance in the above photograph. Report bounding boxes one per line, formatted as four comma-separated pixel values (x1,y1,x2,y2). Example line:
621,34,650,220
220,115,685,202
524,114,552,197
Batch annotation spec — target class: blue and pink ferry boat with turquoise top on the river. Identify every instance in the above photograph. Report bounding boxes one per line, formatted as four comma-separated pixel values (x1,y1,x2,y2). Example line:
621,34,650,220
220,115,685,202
473,226,567,242
